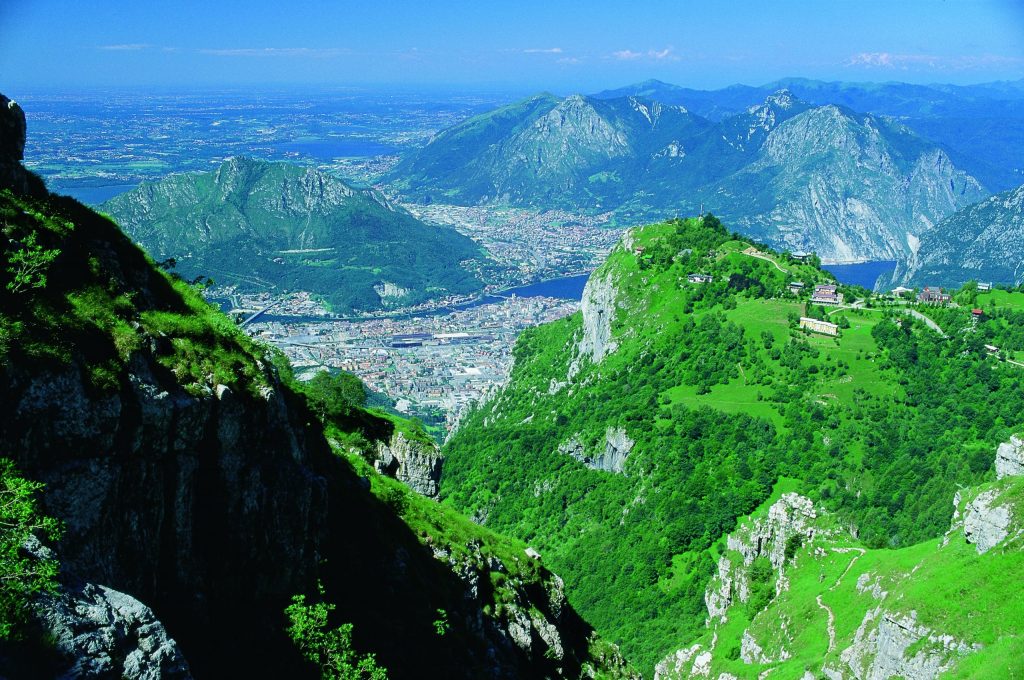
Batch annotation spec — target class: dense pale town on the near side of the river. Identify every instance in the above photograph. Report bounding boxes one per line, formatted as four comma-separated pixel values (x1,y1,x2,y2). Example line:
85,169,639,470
223,293,580,431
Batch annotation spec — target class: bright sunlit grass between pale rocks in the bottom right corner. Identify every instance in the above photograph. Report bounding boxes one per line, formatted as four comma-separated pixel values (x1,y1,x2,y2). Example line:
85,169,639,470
681,478,1024,679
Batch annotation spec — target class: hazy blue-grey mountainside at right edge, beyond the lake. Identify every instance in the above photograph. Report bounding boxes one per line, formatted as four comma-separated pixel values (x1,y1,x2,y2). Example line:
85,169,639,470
892,186,1024,287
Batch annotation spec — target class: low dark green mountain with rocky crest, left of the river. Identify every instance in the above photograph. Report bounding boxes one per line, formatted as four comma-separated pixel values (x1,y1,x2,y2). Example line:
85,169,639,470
101,158,485,311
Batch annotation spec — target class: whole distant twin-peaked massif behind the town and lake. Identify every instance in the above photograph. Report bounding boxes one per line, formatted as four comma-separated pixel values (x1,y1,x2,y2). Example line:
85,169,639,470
389,90,988,261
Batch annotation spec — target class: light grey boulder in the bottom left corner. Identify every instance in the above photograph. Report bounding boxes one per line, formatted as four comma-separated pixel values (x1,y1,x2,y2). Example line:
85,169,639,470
34,584,191,680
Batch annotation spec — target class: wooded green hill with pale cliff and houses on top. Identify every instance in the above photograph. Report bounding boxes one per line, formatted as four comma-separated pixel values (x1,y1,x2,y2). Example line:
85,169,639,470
441,218,1024,672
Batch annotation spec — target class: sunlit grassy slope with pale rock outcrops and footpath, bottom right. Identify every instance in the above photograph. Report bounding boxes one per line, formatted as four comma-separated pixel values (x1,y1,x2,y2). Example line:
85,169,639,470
658,438,1024,680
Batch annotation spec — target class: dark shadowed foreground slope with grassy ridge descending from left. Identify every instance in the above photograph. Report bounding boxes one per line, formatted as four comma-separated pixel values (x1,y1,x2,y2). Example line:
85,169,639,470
0,98,633,678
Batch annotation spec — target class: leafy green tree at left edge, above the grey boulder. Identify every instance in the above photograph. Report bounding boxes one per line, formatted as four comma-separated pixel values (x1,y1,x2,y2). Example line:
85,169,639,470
0,459,60,639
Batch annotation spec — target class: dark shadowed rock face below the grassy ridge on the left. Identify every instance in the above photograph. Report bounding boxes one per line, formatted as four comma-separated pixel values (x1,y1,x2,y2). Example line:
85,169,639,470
0,350,327,675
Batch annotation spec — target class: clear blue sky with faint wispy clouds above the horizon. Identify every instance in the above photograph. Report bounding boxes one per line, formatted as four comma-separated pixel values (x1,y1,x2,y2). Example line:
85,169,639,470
0,0,1024,93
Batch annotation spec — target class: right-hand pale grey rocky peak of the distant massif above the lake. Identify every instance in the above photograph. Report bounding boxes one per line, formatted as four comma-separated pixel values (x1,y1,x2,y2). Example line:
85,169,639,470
723,105,985,261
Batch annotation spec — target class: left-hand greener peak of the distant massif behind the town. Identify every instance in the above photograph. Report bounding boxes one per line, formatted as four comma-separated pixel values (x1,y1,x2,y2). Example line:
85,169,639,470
391,94,711,210
